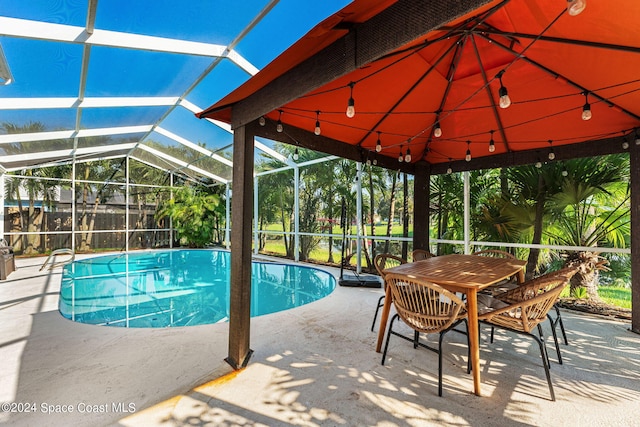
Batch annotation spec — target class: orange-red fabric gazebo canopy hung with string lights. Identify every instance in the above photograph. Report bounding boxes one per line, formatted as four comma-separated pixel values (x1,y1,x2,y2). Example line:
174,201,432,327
199,0,640,173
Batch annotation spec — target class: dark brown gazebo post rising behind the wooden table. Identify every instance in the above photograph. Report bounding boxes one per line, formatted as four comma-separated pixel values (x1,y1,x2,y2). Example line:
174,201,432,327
413,162,431,250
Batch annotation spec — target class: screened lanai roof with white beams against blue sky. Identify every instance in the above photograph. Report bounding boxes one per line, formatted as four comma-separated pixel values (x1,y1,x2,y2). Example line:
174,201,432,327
0,0,348,183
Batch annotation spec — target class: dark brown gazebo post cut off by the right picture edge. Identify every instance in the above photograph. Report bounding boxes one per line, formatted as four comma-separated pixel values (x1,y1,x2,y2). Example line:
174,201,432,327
629,144,640,333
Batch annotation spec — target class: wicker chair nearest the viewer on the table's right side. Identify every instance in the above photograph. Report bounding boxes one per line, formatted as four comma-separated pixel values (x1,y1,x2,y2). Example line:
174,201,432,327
478,275,568,401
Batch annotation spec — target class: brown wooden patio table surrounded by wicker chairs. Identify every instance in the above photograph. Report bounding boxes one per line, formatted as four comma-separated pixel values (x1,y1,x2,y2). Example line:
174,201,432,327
376,254,526,396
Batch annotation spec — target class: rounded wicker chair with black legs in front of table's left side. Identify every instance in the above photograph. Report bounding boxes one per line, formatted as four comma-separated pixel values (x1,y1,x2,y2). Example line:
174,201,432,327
382,274,471,396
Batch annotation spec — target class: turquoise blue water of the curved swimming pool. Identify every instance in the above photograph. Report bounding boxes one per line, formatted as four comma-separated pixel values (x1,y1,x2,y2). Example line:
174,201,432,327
59,249,336,328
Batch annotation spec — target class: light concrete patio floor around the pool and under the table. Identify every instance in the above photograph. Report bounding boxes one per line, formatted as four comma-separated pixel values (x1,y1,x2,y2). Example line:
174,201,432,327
0,252,640,426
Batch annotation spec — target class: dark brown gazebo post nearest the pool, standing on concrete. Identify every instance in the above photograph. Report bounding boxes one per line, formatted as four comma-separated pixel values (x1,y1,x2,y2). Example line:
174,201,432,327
225,126,254,370
